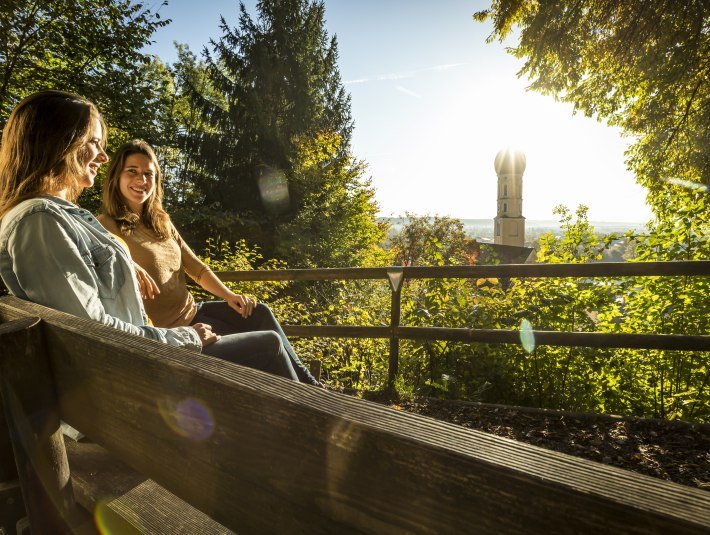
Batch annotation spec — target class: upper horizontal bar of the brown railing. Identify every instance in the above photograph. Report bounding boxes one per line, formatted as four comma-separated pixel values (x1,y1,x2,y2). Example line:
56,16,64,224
217,260,710,282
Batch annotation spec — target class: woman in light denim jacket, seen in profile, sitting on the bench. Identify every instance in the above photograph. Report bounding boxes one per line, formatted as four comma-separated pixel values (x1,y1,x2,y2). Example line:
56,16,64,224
0,91,298,381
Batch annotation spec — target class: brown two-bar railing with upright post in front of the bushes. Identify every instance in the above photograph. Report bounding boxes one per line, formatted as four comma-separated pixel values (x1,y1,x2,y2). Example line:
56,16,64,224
217,261,710,385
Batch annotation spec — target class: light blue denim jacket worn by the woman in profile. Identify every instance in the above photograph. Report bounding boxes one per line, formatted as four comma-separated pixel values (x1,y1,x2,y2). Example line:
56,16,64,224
0,196,202,351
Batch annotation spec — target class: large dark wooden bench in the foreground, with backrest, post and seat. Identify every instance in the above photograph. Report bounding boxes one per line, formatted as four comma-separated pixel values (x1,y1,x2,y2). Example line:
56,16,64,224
0,297,710,534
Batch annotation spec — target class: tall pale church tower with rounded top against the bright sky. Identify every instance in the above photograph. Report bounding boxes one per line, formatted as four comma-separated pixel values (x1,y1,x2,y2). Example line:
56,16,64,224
493,149,525,247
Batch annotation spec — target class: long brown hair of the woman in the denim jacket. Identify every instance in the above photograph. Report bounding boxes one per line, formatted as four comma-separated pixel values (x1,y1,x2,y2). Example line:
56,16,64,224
0,90,106,218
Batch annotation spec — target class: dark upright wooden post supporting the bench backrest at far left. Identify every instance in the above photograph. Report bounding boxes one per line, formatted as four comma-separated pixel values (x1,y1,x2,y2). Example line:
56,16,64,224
0,317,93,534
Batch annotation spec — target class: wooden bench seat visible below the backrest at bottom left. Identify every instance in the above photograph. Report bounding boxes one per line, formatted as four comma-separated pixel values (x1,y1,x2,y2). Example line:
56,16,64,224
66,440,234,535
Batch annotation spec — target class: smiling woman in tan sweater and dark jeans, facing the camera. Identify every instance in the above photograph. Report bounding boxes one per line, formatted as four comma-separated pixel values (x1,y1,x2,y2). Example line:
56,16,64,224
99,140,319,385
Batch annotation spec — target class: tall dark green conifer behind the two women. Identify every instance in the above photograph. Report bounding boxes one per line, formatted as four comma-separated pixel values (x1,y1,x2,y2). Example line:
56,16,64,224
188,0,361,264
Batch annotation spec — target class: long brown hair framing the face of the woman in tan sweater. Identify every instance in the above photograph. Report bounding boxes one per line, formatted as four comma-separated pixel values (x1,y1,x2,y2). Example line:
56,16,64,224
101,139,173,240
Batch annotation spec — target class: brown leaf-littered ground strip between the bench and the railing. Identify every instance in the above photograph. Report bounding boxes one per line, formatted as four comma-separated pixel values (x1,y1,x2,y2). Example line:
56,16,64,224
388,398,710,491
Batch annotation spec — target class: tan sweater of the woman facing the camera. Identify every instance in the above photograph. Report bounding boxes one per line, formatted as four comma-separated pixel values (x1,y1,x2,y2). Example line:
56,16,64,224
98,214,206,327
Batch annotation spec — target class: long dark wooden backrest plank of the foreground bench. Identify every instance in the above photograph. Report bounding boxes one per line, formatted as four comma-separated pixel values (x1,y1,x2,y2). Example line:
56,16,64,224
0,300,710,533
